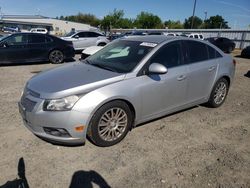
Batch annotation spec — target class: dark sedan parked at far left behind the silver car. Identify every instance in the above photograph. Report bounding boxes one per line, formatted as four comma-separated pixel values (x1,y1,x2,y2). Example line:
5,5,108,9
0,33,75,64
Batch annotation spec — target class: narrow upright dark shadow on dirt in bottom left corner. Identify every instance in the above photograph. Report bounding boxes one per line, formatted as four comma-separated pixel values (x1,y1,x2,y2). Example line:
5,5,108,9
0,157,29,188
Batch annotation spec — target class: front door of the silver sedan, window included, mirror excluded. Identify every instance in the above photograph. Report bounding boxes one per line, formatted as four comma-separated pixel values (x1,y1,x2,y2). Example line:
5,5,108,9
139,41,187,119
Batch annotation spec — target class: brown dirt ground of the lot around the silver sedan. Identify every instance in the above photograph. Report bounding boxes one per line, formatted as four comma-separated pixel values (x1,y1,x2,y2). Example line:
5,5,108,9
0,55,250,188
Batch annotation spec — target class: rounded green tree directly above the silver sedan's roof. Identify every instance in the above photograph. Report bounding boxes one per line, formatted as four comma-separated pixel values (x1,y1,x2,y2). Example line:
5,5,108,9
134,12,163,29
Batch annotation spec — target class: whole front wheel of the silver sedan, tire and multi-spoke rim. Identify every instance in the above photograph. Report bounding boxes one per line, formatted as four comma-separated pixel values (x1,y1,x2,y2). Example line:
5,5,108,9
88,100,132,147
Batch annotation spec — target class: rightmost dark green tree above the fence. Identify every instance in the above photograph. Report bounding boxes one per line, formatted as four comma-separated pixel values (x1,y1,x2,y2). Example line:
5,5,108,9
204,15,230,29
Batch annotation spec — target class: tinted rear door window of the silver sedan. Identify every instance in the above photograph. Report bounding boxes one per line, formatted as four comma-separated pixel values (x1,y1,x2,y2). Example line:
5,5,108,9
186,41,208,63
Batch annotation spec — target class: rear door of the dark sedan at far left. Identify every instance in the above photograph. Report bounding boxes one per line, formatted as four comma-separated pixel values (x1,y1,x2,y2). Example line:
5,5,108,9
27,33,48,62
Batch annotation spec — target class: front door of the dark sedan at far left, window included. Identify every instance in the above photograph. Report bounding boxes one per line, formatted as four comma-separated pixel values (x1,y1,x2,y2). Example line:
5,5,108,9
0,34,28,63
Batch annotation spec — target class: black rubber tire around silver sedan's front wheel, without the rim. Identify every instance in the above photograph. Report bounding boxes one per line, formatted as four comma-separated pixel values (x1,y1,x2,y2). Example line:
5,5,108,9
88,100,133,147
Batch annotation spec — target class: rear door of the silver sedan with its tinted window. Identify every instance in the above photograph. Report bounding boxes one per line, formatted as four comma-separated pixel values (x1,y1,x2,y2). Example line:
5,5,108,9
184,40,218,103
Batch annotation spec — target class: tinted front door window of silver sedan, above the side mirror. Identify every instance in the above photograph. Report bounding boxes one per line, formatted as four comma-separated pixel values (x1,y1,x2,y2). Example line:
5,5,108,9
150,42,181,68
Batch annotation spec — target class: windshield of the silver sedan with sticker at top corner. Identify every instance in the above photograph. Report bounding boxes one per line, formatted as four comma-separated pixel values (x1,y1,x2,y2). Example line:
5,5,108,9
86,40,157,73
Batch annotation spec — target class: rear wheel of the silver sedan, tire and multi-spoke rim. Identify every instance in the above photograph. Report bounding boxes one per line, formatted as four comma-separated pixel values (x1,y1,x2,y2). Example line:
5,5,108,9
207,78,229,108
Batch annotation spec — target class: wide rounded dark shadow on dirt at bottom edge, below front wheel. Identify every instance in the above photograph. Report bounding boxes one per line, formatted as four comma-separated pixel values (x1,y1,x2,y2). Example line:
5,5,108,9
69,170,111,188
